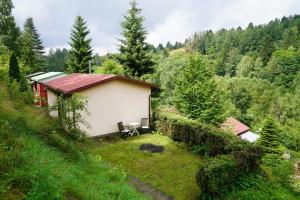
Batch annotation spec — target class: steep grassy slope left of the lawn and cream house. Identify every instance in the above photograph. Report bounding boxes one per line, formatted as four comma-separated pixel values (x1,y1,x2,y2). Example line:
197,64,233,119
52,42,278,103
0,88,146,200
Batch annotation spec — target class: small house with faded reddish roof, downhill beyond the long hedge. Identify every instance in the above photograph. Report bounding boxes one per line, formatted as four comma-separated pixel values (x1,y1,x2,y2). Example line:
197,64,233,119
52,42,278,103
221,117,259,142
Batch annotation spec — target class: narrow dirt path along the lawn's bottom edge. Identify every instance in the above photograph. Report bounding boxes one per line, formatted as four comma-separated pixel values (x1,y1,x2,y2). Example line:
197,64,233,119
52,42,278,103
129,176,174,200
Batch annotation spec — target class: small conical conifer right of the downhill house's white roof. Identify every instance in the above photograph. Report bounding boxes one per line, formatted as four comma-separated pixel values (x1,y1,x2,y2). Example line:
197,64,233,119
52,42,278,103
259,117,280,148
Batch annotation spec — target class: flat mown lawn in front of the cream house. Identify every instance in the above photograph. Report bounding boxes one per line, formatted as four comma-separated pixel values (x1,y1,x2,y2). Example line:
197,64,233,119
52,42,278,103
92,134,201,199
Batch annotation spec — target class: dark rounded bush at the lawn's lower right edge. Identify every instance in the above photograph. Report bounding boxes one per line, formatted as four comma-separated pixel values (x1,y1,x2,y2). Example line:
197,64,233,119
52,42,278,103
196,147,261,199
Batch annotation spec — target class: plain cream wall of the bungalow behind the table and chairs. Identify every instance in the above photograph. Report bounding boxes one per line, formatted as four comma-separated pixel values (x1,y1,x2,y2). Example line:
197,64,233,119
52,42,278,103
48,80,151,136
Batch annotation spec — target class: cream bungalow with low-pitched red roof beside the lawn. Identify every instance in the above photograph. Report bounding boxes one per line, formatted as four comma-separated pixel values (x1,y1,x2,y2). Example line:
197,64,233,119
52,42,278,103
43,74,155,136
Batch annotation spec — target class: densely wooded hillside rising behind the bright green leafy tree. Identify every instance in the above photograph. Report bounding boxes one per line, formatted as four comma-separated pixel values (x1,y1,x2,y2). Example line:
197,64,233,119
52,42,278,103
149,15,300,149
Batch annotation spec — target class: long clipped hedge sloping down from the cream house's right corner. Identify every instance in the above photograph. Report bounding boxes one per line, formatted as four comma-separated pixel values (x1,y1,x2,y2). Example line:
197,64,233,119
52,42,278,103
156,110,249,156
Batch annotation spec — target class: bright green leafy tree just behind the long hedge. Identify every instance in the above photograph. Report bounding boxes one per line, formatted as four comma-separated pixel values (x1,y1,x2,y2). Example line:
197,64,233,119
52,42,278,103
174,56,224,124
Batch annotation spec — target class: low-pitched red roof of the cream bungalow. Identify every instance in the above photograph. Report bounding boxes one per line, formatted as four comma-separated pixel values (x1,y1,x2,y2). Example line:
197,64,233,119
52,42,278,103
43,73,155,94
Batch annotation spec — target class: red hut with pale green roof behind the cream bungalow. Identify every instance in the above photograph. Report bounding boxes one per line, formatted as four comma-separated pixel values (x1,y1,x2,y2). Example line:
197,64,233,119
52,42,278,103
30,72,65,106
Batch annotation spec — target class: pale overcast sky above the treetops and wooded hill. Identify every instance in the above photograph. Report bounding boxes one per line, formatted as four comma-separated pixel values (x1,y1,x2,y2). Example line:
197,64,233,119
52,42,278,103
13,0,300,54
